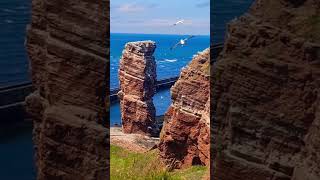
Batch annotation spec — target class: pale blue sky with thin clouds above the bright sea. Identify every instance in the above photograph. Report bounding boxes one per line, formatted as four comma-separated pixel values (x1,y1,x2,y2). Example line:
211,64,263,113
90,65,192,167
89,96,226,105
110,0,210,35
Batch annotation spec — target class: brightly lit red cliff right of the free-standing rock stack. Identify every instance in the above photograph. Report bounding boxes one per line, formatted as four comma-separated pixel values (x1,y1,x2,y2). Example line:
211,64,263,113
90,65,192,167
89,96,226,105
159,49,210,168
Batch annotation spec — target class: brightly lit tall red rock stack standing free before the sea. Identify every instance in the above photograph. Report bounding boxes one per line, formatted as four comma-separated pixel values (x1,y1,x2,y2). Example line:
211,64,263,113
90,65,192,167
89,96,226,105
118,41,156,134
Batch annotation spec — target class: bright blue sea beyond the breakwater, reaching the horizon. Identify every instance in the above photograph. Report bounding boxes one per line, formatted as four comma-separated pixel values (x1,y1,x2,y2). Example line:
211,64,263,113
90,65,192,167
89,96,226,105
110,33,210,89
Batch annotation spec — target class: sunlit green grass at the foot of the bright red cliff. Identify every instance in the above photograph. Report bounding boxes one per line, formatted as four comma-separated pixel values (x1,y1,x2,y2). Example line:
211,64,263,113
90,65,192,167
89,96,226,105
110,145,208,180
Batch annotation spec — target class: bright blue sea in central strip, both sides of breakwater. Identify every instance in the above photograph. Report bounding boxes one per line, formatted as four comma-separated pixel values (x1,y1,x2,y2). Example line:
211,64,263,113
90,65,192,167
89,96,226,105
110,33,210,125
